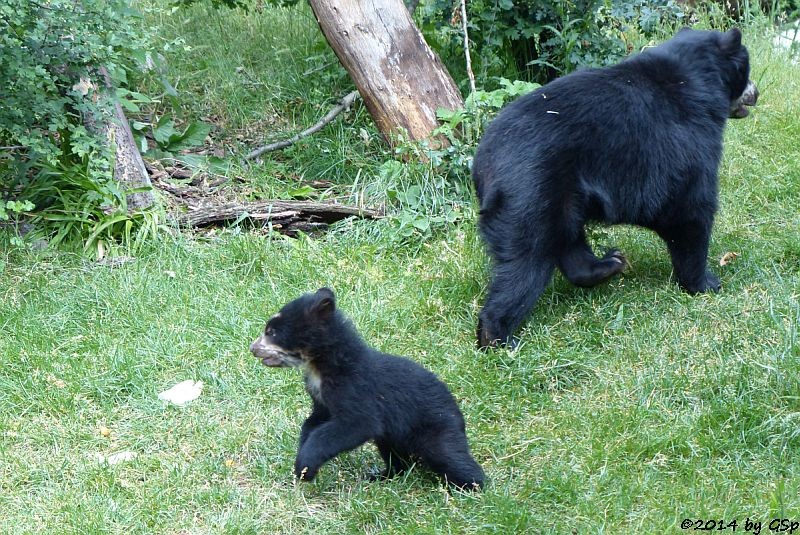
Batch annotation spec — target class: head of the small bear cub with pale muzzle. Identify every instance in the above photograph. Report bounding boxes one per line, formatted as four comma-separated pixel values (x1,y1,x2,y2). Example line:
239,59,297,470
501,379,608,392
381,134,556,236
250,288,336,367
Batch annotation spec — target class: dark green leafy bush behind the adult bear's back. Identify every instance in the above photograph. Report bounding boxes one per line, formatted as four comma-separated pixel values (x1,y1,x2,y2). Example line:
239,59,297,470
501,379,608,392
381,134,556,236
420,0,684,82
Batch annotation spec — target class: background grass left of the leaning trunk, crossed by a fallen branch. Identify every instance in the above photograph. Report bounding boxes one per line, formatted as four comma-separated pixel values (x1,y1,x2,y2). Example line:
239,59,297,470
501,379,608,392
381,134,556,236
140,0,387,198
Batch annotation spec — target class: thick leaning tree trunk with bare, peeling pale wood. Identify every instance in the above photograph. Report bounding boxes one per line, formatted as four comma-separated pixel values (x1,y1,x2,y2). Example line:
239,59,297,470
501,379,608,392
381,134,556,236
309,0,464,147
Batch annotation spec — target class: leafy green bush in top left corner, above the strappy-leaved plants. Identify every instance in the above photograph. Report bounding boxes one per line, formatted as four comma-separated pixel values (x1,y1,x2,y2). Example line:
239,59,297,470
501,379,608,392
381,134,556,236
0,0,152,164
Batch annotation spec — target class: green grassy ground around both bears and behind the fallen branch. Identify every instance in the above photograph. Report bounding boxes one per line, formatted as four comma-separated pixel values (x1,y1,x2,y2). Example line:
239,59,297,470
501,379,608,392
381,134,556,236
0,5,800,534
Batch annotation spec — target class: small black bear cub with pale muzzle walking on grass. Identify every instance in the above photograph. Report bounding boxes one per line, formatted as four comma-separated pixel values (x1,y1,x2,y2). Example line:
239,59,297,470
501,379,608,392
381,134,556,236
250,288,484,490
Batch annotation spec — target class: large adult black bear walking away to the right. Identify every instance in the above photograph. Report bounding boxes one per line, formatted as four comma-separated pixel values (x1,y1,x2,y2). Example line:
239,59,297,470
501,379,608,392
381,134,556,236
472,29,757,347
